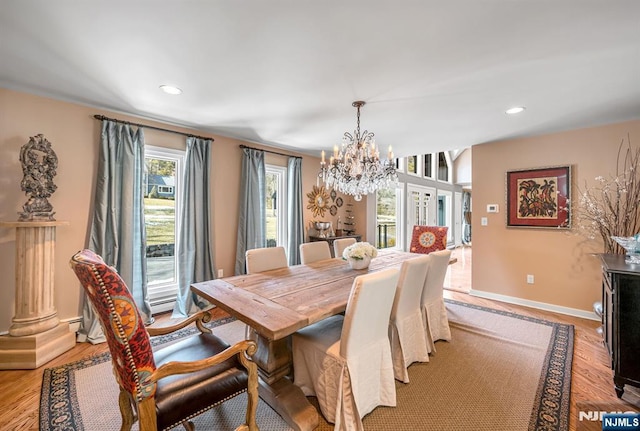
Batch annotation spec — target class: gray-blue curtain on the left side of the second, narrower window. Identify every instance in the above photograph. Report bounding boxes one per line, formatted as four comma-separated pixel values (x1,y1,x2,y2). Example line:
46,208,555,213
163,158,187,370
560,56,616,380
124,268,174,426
235,148,267,275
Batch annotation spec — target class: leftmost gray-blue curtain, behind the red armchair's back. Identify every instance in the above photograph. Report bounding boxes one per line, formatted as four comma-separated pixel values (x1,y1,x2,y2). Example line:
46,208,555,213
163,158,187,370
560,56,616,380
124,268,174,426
78,120,153,344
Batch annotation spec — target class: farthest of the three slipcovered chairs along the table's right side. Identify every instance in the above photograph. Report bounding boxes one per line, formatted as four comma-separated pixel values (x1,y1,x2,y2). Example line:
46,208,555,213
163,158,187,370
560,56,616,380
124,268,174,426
420,250,451,353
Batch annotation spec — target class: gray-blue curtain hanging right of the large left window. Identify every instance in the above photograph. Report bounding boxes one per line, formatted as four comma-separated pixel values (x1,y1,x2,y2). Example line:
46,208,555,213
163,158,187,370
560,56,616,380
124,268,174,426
173,136,214,317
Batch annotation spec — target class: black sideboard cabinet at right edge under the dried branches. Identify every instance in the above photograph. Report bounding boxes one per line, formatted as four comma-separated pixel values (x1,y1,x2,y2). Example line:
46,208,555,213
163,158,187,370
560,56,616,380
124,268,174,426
600,254,640,398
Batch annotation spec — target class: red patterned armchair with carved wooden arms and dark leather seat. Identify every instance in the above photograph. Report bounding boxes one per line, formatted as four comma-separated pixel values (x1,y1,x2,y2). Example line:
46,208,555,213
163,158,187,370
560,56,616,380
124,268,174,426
70,250,258,431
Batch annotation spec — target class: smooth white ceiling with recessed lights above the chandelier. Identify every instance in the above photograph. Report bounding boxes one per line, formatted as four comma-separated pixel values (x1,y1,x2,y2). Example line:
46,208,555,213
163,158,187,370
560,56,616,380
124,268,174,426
0,0,640,156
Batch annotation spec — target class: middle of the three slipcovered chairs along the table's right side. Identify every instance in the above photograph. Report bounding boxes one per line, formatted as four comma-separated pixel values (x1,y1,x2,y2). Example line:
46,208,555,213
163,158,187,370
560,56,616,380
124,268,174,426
389,255,431,383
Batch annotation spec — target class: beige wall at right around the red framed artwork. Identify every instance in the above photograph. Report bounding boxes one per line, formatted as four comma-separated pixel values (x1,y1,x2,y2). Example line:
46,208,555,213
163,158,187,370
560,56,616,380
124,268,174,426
472,121,640,311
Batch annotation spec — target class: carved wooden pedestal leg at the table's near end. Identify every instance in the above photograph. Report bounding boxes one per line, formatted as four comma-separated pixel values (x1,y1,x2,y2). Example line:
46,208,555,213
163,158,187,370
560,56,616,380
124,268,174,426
251,331,319,431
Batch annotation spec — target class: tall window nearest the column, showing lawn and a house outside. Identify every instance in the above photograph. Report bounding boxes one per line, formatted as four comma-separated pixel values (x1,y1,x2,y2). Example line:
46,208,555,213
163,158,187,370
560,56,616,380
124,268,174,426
144,146,184,313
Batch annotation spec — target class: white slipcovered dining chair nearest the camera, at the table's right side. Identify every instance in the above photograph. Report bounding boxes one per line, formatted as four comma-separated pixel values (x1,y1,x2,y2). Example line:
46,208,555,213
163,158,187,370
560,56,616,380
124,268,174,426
292,268,398,431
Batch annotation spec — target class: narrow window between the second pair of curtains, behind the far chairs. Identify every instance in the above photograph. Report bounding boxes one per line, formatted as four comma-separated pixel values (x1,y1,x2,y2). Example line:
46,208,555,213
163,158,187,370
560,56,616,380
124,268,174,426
265,165,287,247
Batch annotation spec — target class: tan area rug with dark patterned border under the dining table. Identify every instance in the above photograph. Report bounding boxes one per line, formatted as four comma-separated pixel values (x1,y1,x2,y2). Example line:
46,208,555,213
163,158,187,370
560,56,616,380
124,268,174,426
40,300,573,431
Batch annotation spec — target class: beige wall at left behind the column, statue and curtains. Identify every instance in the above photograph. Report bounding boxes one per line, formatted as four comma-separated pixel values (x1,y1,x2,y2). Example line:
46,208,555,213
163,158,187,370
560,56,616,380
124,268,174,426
0,89,366,333
